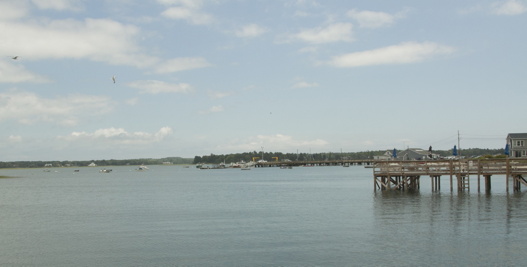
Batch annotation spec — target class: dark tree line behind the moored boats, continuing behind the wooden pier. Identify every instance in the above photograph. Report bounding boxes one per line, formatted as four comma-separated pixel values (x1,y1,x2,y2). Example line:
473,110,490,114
193,148,504,164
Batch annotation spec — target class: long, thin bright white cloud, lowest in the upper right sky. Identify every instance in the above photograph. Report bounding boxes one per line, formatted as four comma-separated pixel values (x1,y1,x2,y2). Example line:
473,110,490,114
329,42,455,67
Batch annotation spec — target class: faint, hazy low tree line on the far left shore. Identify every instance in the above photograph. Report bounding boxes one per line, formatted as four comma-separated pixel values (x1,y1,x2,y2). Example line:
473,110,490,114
0,157,192,168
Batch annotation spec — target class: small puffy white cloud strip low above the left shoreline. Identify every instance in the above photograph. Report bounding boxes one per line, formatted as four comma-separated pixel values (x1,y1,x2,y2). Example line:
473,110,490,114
59,127,173,145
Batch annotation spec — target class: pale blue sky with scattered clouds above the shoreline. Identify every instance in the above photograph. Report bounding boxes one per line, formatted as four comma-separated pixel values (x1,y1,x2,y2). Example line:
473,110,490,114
0,0,527,161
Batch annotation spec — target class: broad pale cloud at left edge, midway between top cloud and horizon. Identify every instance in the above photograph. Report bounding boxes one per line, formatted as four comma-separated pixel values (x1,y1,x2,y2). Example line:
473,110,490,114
0,91,112,125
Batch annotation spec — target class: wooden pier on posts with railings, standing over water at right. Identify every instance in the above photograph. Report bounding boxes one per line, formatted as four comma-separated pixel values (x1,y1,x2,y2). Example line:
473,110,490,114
373,158,527,192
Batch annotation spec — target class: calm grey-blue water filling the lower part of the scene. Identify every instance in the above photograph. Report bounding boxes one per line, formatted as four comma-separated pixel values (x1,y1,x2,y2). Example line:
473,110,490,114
0,166,527,266
